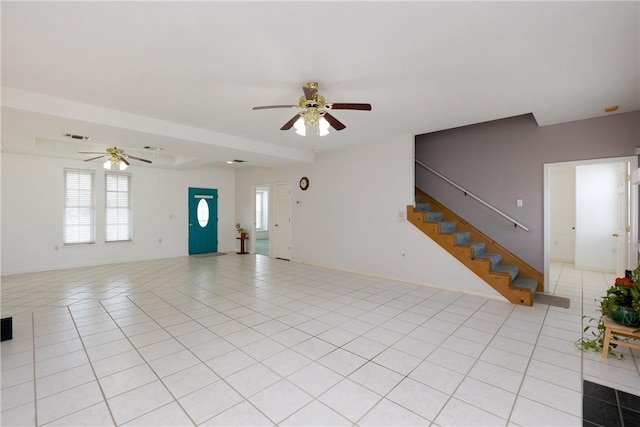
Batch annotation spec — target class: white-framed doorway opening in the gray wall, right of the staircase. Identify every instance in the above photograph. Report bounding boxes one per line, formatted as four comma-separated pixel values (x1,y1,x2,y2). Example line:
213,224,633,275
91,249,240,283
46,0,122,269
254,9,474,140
543,156,638,291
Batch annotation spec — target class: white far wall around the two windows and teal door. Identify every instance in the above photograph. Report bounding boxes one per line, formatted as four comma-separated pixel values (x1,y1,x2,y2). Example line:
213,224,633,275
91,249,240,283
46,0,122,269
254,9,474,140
1,153,236,274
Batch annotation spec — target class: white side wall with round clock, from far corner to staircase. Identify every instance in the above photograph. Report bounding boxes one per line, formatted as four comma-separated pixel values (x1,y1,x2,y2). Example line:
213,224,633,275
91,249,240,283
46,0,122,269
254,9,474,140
236,136,502,298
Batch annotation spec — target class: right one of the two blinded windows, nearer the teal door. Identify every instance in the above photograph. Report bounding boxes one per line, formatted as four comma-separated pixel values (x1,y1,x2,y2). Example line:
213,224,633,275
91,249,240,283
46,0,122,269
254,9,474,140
105,173,131,242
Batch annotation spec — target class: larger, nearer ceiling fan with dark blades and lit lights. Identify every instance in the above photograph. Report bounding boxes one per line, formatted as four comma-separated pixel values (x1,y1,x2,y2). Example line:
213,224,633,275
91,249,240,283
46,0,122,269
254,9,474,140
253,82,371,136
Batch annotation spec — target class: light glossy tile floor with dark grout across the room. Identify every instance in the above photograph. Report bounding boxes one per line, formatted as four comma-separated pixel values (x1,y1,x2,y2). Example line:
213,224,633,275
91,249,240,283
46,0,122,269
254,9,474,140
1,254,640,426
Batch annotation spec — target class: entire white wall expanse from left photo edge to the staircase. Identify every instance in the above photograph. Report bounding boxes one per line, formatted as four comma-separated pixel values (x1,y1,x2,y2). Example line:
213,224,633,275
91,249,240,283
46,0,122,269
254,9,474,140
1,140,508,298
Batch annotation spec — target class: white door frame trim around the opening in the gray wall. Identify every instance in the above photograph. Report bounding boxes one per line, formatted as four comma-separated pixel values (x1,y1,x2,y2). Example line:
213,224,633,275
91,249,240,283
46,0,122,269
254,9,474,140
543,156,638,291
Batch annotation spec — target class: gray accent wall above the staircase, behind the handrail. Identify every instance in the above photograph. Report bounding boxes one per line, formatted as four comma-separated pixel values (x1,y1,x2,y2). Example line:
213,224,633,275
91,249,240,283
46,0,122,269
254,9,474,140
415,111,640,271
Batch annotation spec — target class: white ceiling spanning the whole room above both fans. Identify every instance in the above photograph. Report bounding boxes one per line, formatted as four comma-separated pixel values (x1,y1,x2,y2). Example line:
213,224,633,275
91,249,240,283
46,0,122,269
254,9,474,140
1,1,640,168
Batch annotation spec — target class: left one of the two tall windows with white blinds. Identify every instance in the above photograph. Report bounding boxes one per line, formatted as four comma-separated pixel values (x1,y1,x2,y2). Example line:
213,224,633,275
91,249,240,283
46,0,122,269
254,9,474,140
63,170,95,245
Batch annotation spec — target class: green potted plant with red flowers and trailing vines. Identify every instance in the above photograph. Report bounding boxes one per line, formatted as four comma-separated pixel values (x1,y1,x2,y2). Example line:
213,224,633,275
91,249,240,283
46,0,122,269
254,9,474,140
576,265,640,358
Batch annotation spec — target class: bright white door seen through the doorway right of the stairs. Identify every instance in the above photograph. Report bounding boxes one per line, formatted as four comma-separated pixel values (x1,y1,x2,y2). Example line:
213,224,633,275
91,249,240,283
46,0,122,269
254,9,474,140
575,163,620,273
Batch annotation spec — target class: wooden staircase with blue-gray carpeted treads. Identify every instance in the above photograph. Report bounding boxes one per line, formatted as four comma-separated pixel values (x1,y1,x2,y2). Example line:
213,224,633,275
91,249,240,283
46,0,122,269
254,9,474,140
407,189,544,306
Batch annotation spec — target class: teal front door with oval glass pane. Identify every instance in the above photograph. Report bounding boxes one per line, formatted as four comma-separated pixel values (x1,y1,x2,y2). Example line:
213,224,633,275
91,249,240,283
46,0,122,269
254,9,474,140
189,187,218,255
